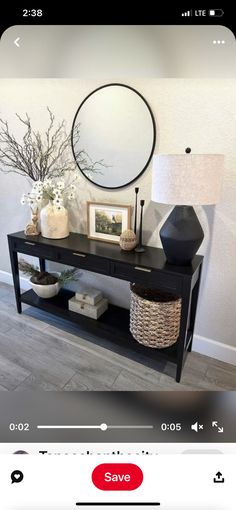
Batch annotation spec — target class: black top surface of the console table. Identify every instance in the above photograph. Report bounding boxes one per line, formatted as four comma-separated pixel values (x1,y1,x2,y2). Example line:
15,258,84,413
8,231,203,276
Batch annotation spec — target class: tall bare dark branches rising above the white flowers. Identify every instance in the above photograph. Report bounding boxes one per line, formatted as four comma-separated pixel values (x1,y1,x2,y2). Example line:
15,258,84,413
0,107,103,182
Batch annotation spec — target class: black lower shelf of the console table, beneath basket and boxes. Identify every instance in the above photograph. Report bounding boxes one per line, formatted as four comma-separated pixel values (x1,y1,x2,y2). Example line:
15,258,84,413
21,289,183,363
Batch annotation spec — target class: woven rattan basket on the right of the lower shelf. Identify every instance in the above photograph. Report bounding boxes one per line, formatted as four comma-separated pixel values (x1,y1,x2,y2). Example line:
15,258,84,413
130,283,181,349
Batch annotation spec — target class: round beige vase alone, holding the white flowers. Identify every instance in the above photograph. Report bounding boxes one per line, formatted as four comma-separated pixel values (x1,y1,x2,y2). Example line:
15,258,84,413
40,202,70,239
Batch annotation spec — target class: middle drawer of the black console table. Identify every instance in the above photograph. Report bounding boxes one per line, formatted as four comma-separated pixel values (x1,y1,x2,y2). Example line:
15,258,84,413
57,250,109,274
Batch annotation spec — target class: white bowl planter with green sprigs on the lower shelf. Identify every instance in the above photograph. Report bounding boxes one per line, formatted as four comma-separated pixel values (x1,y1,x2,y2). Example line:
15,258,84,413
19,259,79,299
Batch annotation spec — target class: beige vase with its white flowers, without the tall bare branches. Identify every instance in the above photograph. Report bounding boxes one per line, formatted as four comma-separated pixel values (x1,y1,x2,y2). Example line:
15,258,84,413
21,178,75,239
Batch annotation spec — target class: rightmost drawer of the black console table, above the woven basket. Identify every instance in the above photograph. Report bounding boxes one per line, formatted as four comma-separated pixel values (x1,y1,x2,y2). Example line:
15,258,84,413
111,263,182,292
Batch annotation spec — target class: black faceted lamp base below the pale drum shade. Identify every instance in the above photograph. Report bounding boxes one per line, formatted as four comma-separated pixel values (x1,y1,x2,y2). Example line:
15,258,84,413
160,205,204,266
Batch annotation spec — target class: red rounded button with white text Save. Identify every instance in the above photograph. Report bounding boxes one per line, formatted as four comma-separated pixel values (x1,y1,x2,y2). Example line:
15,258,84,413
92,464,143,491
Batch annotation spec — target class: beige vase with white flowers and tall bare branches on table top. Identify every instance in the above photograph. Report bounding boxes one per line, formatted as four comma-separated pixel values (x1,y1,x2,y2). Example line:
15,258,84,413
0,107,106,239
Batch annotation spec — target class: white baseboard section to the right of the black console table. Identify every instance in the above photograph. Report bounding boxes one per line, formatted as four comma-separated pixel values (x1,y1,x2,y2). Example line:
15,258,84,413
193,335,236,366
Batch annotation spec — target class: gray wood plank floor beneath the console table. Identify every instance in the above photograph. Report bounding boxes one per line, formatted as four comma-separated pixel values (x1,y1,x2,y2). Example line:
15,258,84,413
0,283,236,391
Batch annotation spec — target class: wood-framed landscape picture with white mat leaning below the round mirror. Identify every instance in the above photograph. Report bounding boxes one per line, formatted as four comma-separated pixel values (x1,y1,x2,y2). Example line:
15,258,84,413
87,202,131,244
